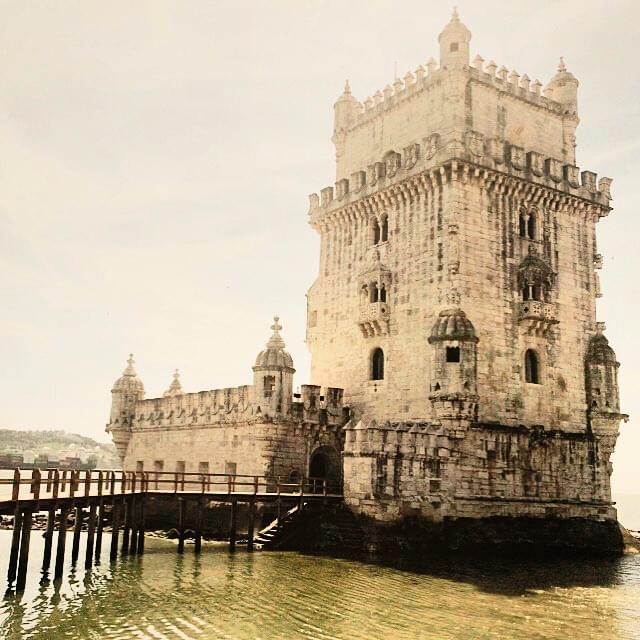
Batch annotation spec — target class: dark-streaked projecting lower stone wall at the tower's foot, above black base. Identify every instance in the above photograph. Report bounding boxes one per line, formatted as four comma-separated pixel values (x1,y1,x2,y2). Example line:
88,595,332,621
344,421,615,522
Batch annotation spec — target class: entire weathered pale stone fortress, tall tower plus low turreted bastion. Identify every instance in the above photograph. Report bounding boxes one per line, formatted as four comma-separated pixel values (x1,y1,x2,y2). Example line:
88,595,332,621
107,13,626,546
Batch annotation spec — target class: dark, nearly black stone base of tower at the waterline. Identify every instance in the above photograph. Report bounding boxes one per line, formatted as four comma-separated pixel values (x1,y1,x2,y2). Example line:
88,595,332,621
291,505,624,556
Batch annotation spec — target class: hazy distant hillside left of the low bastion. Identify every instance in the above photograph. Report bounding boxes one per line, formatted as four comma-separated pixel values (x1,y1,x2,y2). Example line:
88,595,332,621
0,429,119,467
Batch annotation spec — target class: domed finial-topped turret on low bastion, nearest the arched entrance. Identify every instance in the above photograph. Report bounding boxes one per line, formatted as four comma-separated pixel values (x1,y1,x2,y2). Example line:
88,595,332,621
253,316,296,415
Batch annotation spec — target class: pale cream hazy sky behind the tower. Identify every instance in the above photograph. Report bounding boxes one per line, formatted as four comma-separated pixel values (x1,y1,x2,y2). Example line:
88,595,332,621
0,0,640,493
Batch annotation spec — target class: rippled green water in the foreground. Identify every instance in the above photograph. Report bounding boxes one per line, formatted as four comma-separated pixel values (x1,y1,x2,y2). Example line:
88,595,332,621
0,531,640,640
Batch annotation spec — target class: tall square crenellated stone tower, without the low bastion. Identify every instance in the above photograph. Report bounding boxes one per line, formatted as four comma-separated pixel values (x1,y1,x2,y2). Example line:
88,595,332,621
307,12,624,540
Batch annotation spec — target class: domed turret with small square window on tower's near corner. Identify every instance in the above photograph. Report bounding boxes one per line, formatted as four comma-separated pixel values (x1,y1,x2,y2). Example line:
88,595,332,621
429,308,478,420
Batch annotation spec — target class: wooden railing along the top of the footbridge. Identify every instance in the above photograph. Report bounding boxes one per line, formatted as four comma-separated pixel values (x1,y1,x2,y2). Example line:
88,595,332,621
0,469,342,503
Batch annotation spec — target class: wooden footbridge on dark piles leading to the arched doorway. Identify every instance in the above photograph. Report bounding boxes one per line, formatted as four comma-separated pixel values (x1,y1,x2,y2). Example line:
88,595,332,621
0,469,342,591
